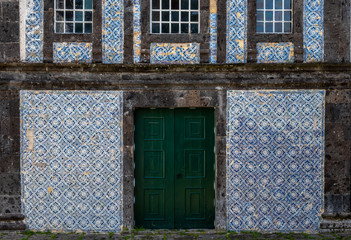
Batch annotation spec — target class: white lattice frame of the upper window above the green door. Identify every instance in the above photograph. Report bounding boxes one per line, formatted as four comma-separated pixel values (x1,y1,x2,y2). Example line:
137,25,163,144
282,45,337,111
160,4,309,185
150,0,201,34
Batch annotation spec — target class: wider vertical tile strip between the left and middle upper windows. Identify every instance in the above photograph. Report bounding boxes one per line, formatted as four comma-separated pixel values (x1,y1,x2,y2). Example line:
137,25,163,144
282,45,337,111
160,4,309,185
102,0,124,64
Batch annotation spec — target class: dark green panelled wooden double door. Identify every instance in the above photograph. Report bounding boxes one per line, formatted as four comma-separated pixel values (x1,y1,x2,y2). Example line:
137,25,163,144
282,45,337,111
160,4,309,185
134,109,215,228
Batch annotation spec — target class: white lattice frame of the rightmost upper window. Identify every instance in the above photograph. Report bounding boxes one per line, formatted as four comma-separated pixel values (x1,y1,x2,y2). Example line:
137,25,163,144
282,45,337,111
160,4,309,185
255,0,294,34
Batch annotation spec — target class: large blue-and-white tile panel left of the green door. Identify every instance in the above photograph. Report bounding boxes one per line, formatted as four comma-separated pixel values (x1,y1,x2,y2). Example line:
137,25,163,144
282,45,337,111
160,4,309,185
20,91,123,232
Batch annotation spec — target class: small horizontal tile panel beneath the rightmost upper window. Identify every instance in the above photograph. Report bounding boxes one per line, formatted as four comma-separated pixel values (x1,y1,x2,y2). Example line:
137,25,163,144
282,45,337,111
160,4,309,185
257,43,294,63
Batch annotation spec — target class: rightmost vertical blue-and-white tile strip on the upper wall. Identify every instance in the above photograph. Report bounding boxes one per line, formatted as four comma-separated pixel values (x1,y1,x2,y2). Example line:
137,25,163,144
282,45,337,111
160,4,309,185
303,0,324,62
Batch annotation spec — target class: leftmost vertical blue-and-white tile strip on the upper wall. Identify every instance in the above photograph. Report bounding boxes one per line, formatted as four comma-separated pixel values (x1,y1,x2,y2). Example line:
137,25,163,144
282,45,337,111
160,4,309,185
24,0,44,63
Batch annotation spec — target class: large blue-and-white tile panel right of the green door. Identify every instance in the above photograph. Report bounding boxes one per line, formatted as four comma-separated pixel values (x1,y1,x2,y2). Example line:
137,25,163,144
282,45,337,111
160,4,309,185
226,90,325,232
